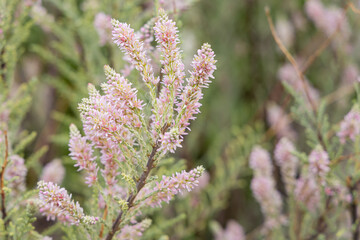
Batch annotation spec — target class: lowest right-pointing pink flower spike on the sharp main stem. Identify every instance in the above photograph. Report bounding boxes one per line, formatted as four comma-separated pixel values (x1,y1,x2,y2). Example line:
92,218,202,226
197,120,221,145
138,166,205,207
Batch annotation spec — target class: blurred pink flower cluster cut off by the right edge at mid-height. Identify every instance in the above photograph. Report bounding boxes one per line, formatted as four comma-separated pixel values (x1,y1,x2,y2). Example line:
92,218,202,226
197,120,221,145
337,107,360,144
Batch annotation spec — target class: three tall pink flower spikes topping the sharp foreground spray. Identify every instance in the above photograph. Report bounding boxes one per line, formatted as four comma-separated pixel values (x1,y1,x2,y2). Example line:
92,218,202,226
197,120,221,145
112,12,216,154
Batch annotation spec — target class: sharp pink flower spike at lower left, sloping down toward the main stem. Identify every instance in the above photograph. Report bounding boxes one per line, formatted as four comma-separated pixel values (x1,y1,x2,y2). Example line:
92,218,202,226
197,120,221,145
38,181,98,225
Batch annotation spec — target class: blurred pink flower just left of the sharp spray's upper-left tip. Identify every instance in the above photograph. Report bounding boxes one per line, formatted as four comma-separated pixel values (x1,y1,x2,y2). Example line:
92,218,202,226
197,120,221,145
94,12,112,46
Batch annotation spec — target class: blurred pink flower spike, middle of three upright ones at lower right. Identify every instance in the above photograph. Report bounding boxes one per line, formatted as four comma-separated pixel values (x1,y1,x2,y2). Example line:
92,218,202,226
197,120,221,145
274,138,299,194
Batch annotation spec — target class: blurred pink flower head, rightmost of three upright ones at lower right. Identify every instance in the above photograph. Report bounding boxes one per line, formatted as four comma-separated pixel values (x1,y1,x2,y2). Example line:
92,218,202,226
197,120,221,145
309,146,330,185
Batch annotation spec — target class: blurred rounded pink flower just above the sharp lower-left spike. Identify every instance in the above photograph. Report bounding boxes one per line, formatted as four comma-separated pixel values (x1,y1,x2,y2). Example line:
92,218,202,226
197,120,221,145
40,159,65,184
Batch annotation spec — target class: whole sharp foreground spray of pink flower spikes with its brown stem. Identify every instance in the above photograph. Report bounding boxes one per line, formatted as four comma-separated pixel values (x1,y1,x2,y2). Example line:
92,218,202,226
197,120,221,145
38,11,216,240
